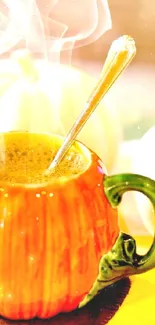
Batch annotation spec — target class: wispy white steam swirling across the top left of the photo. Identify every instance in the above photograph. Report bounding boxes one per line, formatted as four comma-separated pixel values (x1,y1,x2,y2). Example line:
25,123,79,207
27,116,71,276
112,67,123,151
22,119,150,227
0,0,111,56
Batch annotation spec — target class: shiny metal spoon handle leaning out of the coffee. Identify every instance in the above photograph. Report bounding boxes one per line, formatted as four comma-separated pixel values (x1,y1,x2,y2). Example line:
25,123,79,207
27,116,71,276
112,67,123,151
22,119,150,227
47,35,136,172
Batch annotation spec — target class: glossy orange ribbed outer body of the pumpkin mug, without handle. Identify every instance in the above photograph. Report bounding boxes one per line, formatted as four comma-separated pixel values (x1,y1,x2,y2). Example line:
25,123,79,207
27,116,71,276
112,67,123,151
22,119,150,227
0,132,119,319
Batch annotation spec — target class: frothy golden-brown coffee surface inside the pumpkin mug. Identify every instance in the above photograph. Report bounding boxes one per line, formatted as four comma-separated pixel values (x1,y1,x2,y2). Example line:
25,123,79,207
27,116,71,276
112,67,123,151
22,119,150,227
0,132,88,184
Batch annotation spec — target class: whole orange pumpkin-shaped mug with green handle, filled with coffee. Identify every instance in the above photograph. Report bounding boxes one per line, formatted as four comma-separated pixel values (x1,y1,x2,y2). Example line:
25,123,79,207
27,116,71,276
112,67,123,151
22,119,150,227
0,132,155,319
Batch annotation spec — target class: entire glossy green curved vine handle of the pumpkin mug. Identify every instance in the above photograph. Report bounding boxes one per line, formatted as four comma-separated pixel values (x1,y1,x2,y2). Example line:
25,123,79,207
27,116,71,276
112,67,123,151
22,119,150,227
79,174,155,307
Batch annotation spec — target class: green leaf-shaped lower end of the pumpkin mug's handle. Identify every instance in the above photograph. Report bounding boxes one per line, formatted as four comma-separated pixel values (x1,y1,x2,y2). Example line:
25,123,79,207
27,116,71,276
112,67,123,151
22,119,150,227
79,233,138,308
